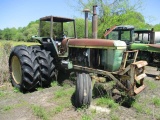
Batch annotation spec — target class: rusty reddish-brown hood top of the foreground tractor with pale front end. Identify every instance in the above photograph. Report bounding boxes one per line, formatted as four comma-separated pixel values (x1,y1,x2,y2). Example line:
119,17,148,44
62,38,126,49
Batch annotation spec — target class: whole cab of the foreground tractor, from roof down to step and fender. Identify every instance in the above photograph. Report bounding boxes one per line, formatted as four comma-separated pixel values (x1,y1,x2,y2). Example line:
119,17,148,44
32,16,77,56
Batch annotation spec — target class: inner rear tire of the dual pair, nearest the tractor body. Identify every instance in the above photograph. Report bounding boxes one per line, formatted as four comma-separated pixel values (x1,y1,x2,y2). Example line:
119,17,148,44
34,47,55,87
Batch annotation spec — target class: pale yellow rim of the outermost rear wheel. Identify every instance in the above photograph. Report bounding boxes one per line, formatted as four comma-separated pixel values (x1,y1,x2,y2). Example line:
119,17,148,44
11,56,22,84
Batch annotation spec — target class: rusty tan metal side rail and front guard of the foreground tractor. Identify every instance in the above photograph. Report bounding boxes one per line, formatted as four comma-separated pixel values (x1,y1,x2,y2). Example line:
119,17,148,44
73,58,147,96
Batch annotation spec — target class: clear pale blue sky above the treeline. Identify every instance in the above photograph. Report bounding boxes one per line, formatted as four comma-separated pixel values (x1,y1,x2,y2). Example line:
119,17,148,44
0,0,160,30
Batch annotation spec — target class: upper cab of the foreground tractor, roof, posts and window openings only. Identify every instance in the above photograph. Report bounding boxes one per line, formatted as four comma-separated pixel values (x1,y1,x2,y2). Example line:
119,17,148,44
38,16,77,41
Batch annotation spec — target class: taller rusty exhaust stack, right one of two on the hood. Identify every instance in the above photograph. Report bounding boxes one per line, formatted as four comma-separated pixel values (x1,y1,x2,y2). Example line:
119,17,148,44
92,5,98,39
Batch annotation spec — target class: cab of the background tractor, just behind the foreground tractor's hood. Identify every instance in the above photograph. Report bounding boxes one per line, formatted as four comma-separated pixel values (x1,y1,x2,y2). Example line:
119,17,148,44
106,25,134,45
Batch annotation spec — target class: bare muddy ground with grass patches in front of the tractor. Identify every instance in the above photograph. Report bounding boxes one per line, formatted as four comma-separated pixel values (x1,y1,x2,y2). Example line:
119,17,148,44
0,66,160,120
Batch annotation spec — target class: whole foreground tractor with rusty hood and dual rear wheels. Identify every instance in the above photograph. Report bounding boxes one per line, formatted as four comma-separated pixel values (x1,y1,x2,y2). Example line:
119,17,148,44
9,6,147,107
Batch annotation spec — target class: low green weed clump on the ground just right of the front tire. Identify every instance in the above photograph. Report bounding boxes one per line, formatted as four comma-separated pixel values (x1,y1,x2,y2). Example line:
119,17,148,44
96,97,118,109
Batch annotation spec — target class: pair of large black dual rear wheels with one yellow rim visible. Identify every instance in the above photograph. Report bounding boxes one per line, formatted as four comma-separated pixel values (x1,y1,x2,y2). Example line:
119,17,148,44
9,46,55,91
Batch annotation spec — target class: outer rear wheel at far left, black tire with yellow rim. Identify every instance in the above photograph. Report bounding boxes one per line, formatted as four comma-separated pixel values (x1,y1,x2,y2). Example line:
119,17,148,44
9,46,39,91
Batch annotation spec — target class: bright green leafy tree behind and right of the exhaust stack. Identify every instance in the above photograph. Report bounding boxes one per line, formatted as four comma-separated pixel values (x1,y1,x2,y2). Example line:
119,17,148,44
70,0,145,37
